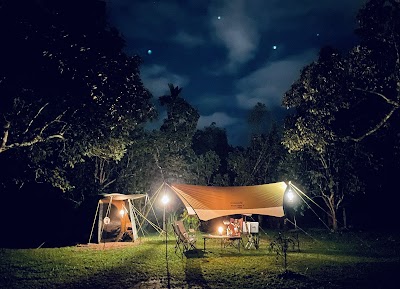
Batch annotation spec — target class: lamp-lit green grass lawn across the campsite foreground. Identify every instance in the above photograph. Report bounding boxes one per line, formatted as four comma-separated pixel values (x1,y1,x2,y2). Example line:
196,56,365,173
0,231,400,289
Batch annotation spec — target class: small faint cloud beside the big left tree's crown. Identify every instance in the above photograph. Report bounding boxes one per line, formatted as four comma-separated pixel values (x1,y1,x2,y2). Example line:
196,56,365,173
141,64,189,97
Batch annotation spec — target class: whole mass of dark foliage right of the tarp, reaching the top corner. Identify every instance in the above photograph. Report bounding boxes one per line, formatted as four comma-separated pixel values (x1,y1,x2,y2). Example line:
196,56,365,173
283,0,400,230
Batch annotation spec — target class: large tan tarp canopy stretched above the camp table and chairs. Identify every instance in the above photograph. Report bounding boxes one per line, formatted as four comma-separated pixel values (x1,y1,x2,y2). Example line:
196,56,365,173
170,182,287,221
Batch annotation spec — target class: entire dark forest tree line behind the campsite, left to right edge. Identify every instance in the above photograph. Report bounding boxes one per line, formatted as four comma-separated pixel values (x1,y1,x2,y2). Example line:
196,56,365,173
0,0,400,234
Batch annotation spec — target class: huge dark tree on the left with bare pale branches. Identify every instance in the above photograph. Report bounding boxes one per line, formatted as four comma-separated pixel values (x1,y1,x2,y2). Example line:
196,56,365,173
0,0,153,200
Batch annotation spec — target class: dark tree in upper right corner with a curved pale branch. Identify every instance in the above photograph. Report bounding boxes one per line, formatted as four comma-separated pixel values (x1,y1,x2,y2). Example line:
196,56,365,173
347,0,400,141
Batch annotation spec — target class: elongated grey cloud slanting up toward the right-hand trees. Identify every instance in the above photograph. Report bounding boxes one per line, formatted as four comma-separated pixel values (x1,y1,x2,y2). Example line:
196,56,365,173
236,50,317,109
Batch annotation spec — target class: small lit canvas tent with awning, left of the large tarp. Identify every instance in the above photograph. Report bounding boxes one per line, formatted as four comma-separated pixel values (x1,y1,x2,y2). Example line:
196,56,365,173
89,193,147,243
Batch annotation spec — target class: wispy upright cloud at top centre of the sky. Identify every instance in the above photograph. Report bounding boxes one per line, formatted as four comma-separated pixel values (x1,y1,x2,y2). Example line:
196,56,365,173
210,0,260,72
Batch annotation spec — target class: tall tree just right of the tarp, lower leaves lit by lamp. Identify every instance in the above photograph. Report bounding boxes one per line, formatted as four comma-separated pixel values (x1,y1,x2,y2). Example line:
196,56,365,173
283,48,363,231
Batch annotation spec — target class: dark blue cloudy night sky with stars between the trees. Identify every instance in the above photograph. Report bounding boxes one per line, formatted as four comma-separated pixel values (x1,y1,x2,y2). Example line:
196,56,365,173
108,0,365,145
